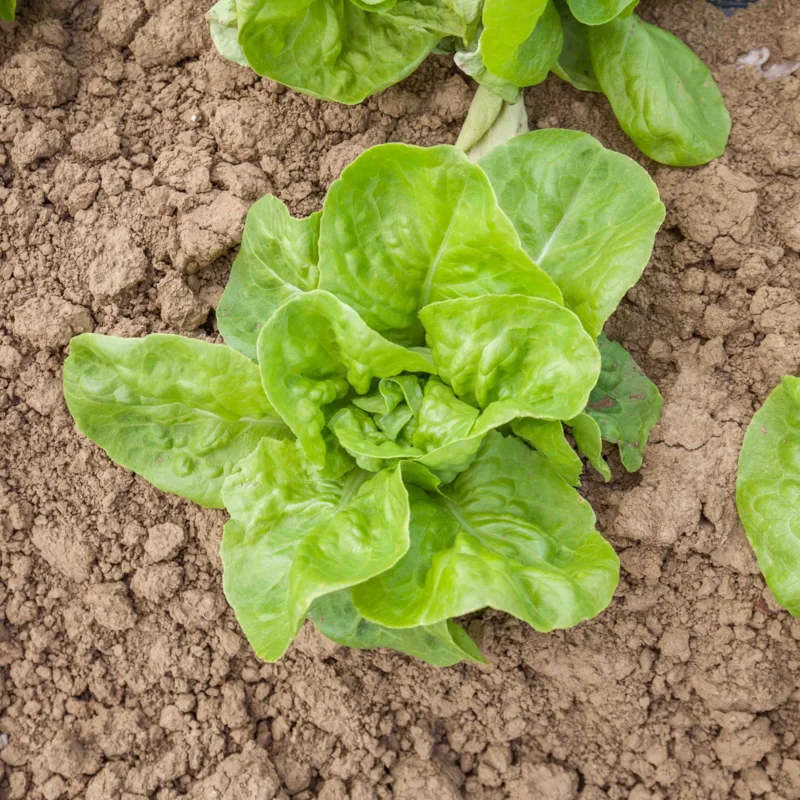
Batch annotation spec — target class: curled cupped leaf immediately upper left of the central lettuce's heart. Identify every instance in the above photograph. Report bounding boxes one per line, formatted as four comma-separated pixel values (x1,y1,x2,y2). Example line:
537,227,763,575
258,290,434,466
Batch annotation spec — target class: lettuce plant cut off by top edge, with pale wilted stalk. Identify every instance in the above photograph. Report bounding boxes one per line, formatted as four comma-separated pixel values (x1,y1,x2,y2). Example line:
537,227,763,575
209,0,731,166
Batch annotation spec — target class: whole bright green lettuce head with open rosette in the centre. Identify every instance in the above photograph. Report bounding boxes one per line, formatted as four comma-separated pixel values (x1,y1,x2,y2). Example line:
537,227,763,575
64,130,664,665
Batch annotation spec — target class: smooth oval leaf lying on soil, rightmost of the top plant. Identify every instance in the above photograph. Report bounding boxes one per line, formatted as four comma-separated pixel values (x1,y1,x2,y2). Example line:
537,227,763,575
590,15,731,167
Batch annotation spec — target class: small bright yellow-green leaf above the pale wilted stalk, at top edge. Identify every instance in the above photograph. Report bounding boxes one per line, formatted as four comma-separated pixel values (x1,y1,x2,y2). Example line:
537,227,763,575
481,0,564,86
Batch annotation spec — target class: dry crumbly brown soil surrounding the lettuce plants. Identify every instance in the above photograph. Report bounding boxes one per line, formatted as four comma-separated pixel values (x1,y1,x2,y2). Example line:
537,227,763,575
0,0,800,800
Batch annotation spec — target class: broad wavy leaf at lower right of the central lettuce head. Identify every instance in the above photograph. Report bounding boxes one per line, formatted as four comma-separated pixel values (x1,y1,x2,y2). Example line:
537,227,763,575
352,433,619,631
